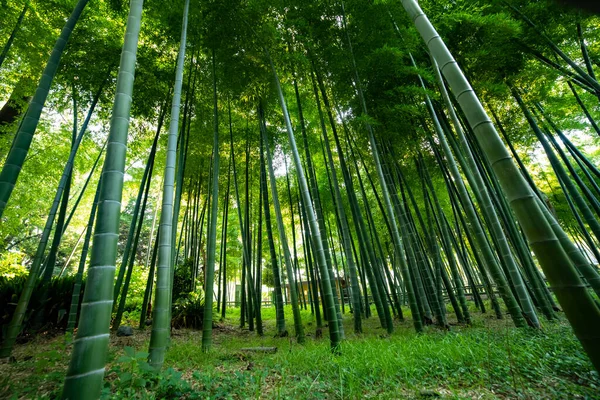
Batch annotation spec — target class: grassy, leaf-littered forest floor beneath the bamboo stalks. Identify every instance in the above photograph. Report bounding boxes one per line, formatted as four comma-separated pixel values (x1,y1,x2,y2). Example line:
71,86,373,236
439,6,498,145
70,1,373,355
0,308,600,399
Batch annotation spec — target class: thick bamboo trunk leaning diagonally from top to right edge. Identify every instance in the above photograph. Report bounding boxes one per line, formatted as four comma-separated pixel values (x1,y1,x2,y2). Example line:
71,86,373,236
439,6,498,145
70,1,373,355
402,0,600,369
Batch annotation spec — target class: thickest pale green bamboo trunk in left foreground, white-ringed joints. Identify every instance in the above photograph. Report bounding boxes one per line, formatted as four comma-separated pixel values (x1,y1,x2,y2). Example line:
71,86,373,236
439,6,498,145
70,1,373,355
62,0,144,399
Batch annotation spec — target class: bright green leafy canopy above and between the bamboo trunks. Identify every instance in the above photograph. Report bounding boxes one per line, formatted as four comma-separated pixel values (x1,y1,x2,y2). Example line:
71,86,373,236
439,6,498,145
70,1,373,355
0,0,600,268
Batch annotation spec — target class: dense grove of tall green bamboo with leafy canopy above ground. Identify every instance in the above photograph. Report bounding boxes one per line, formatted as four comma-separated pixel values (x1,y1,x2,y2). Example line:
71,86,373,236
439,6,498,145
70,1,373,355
0,0,600,398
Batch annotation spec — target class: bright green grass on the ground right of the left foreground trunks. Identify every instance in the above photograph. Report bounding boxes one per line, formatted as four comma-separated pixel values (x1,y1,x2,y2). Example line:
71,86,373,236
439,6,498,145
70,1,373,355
162,314,600,399
